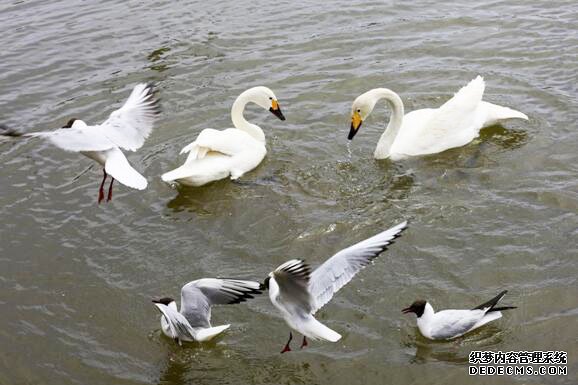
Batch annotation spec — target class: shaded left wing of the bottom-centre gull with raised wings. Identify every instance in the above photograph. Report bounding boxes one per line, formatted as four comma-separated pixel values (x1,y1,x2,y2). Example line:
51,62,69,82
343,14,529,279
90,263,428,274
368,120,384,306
273,259,313,314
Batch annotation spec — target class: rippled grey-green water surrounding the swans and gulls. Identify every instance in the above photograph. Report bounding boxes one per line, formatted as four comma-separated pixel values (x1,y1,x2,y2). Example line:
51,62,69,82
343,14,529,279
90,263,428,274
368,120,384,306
0,0,578,384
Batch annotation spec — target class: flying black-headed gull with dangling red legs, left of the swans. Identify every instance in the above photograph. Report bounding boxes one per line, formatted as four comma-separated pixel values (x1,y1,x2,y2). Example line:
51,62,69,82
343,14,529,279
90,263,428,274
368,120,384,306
0,83,160,203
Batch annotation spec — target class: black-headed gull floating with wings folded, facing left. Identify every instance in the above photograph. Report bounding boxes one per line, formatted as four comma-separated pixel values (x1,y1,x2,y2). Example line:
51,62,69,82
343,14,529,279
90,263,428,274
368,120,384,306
402,290,516,340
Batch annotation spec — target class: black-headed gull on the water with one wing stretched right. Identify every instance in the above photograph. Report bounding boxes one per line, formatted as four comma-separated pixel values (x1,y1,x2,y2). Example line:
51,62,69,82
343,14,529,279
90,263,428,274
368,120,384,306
153,278,262,345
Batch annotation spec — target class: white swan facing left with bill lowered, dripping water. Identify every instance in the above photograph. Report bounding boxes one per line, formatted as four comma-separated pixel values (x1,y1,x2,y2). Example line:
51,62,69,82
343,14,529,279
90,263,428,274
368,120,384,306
348,76,528,161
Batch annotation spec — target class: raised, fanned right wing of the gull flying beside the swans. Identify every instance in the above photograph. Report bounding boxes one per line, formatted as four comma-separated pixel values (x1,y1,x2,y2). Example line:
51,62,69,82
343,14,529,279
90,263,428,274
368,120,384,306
99,83,160,151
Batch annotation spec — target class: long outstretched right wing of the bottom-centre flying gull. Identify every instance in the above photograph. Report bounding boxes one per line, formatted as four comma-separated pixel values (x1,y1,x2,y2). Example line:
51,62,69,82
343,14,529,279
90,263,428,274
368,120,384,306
309,221,407,313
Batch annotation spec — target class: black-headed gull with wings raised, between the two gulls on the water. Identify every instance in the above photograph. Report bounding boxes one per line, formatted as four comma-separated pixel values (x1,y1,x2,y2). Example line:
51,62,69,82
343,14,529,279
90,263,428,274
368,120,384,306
263,222,407,353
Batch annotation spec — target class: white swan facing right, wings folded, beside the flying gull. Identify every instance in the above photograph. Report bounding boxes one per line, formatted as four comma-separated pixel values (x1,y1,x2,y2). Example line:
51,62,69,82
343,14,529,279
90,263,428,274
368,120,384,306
161,87,285,186
